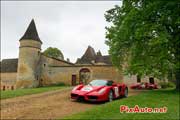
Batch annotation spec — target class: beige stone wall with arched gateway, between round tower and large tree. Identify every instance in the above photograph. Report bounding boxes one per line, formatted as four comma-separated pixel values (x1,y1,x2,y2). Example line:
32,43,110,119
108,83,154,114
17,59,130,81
41,65,123,86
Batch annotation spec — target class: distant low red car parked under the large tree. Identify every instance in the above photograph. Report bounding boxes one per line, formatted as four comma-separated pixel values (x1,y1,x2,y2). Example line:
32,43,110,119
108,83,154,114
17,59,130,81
130,82,158,89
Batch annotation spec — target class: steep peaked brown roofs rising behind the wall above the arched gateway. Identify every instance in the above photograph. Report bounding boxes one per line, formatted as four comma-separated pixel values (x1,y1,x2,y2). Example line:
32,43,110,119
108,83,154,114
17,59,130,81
76,46,112,65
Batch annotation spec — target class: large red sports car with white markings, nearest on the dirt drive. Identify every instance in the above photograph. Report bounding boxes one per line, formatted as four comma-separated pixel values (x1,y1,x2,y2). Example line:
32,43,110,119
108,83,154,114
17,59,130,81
71,80,128,102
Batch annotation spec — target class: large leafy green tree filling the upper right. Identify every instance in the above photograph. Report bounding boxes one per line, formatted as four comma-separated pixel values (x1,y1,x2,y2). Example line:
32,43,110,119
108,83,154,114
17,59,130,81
105,0,180,89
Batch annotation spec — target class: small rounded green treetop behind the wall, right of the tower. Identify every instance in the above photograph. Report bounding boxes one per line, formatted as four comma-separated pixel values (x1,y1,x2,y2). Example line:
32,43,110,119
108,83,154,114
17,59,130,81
43,47,64,60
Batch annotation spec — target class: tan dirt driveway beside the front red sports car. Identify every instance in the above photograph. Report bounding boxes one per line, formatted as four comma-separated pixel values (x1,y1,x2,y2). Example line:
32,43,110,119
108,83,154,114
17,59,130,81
1,87,141,119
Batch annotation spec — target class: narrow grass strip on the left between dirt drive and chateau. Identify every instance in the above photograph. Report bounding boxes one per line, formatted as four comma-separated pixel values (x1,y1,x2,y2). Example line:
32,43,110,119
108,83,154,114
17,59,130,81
1,86,66,99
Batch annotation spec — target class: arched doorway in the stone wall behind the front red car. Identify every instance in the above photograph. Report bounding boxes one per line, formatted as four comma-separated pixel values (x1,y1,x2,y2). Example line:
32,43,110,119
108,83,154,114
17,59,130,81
79,68,90,84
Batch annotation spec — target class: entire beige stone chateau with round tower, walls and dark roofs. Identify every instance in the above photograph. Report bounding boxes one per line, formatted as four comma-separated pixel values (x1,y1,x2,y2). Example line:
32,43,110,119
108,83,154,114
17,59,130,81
0,20,156,90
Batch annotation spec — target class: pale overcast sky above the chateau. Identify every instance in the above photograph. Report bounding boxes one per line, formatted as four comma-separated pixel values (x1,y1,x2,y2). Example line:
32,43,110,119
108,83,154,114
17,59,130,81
1,1,122,62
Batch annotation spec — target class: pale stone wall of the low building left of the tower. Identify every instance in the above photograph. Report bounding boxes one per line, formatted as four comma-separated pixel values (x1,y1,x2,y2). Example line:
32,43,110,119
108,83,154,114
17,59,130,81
0,72,17,90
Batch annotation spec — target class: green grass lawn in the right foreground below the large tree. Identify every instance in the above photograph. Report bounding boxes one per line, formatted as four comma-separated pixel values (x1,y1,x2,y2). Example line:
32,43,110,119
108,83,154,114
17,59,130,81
64,90,180,120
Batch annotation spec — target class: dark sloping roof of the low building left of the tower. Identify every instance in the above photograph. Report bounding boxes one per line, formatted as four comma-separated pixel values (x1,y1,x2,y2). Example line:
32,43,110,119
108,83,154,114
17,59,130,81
0,58,18,73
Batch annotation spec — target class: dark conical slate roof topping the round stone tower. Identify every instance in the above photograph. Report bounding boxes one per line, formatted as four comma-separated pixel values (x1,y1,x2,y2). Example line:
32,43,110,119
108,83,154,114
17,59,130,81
20,19,42,43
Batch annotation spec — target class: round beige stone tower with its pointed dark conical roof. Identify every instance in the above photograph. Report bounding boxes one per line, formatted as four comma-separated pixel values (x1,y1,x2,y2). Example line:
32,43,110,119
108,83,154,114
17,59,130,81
16,19,42,88
